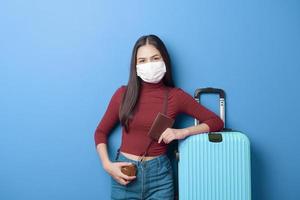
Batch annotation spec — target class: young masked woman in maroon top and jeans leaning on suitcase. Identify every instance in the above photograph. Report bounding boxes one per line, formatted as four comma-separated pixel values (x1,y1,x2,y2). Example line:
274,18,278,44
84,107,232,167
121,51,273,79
94,35,223,200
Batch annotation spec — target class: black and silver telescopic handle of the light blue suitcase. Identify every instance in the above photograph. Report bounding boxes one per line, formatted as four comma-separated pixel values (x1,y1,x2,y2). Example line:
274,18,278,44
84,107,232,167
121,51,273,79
194,87,225,129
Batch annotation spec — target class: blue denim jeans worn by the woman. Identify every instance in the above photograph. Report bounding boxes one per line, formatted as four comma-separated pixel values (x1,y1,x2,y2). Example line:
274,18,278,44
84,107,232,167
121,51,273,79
111,153,174,200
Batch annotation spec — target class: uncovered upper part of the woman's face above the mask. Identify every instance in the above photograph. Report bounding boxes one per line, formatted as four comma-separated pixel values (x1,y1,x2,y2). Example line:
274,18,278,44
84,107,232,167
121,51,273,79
136,44,163,64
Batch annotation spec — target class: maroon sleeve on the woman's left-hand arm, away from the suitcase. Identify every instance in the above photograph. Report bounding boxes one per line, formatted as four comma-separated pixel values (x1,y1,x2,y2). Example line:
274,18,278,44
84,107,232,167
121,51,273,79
94,86,125,147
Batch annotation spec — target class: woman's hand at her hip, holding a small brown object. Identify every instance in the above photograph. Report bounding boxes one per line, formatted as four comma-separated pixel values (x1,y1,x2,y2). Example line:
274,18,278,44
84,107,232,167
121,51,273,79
104,162,136,185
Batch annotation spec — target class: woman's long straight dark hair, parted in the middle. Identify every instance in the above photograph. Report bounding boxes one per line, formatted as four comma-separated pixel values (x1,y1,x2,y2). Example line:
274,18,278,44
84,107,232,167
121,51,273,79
119,35,175,132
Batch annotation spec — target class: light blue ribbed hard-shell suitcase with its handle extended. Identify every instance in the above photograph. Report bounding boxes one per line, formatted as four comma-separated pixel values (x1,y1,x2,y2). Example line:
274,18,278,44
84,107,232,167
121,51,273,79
177,88,251,200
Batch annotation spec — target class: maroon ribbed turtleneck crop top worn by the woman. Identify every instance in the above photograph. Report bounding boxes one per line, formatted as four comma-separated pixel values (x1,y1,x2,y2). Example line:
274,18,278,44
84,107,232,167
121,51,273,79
94,81,224,156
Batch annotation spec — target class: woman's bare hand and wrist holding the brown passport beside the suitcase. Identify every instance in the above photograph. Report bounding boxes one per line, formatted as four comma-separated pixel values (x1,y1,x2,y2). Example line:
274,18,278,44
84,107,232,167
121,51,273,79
158,128,187,144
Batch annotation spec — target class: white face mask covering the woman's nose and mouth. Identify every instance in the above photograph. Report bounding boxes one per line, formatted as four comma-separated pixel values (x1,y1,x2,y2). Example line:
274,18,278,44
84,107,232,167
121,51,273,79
136,61,166,83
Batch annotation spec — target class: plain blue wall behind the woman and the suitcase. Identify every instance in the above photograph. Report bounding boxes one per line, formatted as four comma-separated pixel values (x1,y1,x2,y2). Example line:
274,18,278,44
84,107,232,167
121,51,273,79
0,0,300,200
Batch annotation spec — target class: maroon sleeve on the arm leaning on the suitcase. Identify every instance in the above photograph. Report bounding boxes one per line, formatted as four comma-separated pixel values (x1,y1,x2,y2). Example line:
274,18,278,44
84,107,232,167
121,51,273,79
176,88,224,132
